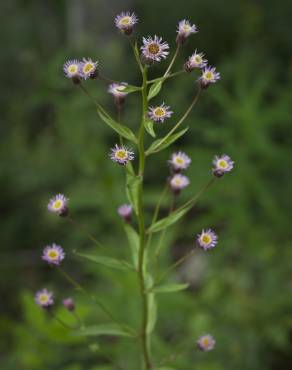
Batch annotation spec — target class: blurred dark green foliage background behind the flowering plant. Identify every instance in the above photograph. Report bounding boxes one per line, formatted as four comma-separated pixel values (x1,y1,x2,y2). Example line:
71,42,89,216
0,0,292,370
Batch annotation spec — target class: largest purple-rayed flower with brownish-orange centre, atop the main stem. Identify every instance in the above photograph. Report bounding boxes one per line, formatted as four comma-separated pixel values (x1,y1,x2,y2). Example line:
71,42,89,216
141,35,169,64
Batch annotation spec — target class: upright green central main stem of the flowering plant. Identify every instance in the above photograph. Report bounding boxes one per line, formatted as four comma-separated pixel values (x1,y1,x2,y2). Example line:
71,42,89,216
138,67,151,370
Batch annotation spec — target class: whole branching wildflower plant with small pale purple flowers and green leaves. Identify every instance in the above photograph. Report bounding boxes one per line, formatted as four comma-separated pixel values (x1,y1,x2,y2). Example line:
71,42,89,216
35,12,234,370
